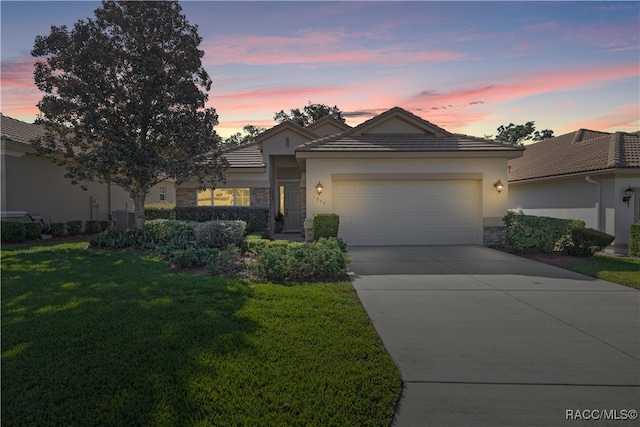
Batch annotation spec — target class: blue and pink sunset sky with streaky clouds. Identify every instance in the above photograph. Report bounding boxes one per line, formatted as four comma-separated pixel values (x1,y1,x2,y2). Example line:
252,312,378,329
0,0,640,137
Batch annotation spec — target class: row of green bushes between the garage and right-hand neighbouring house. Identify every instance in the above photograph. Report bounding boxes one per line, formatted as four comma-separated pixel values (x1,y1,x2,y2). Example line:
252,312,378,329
504,212,614,256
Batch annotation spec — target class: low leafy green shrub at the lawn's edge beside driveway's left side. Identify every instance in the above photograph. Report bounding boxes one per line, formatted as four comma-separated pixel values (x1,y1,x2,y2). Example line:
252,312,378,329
250,237,349,281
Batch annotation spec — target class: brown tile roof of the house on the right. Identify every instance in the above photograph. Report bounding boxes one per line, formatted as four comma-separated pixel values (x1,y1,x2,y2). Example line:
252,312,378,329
509,129,640,182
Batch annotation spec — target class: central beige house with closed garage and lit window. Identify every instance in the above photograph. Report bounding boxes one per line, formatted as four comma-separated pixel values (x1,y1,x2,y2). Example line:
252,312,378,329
176,107,524,246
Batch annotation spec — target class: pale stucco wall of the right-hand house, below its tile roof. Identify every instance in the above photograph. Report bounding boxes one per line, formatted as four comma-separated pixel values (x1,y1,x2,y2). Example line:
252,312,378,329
509,170,640,253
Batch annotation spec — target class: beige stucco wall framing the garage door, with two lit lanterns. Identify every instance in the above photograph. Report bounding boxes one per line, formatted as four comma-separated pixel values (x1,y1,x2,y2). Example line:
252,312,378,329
306,158,509,226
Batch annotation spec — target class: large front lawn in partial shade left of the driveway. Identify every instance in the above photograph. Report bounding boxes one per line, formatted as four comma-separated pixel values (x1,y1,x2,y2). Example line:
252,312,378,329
1,242,401,426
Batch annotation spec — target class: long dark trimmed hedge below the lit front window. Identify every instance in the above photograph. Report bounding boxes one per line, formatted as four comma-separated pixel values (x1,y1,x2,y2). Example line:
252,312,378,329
175,206,270,233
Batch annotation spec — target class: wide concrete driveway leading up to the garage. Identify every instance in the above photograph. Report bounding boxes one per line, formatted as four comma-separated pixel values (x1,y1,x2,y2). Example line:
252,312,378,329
348,246,640,426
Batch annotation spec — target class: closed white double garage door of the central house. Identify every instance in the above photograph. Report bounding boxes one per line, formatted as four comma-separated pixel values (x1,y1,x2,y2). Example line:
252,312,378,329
333,180,482,246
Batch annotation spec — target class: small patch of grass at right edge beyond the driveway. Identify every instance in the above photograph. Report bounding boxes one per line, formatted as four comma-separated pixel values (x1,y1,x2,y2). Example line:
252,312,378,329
568,256,640,289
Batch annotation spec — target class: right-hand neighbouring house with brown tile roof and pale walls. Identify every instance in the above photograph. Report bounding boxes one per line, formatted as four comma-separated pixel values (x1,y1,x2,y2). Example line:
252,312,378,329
509,129,640,253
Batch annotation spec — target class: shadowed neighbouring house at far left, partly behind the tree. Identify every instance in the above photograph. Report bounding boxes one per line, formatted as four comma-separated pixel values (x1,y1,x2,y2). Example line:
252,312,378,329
0,115,175,227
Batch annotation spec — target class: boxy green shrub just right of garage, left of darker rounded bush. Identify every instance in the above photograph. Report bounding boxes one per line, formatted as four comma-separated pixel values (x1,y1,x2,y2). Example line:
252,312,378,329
504,212,585,253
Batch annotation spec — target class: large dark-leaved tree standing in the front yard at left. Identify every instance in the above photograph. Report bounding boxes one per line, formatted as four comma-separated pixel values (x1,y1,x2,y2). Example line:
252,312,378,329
31,1,225,229
